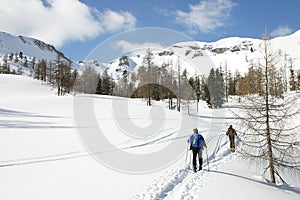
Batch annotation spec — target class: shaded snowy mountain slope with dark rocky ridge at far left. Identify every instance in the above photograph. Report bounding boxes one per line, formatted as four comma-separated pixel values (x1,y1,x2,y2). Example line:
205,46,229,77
0,32,108,75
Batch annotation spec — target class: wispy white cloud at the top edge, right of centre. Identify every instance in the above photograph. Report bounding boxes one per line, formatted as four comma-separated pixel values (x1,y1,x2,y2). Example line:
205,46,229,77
176,0,236,33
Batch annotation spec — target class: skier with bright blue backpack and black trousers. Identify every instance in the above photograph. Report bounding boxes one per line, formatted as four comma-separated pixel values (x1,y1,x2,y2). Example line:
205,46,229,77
188,128,206,172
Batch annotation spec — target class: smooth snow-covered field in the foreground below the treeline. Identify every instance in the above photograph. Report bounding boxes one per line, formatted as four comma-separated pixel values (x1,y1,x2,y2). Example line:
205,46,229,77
0,75,300,200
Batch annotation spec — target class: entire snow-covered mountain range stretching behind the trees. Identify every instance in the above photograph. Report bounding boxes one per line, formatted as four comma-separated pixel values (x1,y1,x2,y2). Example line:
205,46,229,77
0,30,300,80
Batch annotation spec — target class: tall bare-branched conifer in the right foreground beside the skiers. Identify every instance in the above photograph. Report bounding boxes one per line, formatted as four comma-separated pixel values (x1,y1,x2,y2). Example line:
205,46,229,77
235,28,300,183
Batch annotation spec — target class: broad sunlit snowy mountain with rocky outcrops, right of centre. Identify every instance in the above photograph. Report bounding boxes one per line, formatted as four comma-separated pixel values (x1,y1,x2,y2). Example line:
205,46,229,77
103,31,300,78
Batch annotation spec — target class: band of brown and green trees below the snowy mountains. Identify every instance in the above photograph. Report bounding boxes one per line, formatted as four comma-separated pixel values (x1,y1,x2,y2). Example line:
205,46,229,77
0,51,300,104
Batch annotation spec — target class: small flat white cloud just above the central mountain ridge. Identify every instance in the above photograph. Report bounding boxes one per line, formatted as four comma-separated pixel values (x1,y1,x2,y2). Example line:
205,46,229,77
112,40,165,53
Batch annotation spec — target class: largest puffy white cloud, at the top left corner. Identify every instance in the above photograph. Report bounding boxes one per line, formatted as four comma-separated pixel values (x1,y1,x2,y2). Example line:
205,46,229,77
0,0,136,46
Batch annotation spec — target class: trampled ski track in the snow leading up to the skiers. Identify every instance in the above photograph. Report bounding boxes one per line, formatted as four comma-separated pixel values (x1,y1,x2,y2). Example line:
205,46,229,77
132,133,234,200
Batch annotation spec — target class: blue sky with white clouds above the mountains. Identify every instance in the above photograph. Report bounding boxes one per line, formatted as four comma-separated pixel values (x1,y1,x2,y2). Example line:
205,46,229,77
0,0,300,60
